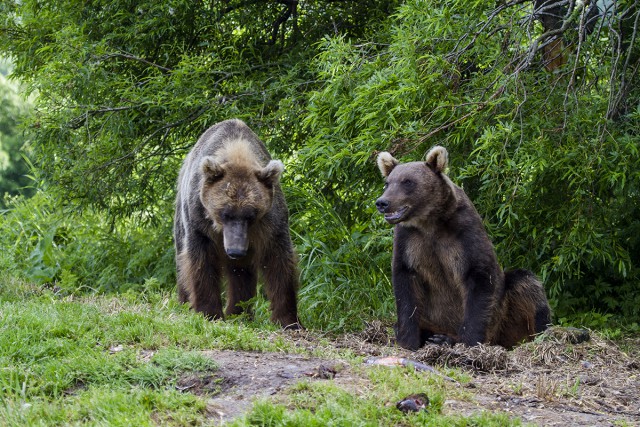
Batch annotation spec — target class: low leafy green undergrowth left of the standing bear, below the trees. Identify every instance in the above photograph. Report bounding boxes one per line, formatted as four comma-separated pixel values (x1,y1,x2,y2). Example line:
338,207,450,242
0,192,175,293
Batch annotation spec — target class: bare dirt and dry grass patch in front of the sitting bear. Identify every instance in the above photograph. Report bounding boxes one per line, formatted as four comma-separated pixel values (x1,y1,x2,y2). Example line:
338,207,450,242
178,323,640,426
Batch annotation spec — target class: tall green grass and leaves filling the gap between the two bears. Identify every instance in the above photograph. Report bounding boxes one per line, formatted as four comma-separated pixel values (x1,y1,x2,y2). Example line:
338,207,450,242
287,185,395,331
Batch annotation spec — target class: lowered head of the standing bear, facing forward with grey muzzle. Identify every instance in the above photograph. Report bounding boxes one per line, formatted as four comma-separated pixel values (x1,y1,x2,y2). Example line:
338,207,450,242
200,142,284,259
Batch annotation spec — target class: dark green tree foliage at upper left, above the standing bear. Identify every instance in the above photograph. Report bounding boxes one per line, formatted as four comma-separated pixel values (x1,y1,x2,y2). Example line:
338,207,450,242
0,0,395,219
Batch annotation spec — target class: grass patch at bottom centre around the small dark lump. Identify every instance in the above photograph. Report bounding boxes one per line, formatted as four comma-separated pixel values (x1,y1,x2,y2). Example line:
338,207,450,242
232,367,521,427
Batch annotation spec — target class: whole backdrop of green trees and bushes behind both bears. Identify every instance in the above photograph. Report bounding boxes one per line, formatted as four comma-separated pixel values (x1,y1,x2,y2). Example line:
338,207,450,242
0,0,640,333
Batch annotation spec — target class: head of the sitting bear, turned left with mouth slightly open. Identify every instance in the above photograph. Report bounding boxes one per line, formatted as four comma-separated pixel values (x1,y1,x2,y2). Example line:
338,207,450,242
376,146,455,225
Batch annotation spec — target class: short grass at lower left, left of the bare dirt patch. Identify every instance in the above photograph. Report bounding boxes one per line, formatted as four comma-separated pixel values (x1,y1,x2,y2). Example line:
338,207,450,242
0,274,287,425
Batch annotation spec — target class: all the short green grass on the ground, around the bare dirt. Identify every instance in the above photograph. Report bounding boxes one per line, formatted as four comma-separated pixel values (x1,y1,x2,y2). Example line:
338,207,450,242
0,278,520,426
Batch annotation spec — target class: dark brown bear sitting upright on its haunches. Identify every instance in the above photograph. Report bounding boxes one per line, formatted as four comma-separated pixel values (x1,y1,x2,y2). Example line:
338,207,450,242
376,146,551,350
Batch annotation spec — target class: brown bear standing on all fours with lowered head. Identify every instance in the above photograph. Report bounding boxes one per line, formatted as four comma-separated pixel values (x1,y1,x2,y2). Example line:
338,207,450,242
174,120,300,329
